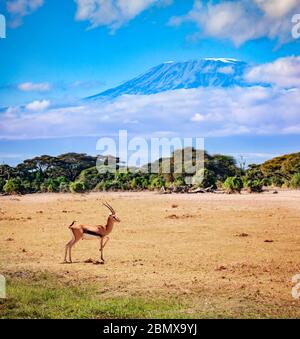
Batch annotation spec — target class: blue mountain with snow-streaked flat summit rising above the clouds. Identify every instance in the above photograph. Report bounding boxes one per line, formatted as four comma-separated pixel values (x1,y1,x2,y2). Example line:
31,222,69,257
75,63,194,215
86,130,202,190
88,58,247,100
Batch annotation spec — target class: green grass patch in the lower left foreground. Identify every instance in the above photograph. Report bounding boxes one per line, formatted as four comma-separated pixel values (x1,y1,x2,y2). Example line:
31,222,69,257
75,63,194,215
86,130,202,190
0,273,195,319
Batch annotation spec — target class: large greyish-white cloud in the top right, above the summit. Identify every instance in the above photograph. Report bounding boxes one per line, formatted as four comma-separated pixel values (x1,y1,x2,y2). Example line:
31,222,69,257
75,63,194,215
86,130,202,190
170,0,300,46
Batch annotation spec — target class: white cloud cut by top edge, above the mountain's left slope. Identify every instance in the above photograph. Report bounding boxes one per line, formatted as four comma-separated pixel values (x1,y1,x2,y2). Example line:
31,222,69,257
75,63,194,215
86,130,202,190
75,0,172,32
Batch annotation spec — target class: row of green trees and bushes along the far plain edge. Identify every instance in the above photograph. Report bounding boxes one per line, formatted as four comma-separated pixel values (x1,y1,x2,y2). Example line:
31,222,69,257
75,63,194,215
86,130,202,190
0,150,300,194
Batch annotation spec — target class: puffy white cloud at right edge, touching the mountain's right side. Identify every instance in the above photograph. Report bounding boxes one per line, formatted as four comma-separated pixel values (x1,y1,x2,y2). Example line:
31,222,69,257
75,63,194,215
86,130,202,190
245,57,300,88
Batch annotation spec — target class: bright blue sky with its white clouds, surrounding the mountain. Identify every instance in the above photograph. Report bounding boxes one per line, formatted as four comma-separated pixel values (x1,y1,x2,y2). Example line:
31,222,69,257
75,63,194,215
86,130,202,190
0,0,300,164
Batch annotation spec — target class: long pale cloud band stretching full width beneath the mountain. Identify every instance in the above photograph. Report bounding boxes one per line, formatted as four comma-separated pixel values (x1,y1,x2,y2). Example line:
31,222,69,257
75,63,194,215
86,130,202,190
0,86,300,139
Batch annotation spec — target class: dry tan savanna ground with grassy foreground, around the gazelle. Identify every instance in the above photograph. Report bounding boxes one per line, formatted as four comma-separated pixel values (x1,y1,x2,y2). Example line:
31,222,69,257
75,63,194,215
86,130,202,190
0,191,300,318
